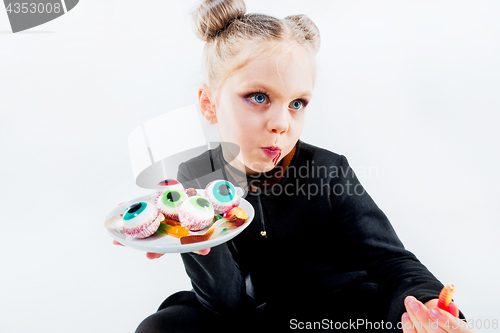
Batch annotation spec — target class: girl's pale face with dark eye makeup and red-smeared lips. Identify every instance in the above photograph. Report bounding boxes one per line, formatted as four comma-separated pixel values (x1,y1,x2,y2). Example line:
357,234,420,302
209,46,314,174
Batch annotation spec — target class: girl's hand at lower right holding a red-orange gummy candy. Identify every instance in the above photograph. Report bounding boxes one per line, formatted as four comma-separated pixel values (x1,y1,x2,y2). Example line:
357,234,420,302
401,296,474,333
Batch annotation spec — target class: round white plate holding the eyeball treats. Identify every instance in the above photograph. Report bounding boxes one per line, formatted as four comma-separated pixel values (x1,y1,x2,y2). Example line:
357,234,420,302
104,190,255,253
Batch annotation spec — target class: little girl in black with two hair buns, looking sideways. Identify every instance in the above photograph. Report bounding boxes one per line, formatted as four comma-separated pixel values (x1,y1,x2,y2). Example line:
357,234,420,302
131,0,470,333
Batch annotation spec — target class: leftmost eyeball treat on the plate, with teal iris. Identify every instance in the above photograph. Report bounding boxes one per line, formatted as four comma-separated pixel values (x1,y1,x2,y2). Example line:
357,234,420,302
122,201,164,238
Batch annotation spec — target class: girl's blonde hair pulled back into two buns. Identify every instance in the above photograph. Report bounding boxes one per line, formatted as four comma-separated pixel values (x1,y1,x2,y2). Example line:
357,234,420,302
193,0,320,98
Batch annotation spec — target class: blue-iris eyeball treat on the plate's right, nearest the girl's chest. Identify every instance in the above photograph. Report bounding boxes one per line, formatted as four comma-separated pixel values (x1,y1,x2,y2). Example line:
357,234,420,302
205,180,241,214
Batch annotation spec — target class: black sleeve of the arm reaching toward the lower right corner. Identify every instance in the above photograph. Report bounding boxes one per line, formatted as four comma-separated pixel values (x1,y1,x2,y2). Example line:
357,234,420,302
332,156,463,332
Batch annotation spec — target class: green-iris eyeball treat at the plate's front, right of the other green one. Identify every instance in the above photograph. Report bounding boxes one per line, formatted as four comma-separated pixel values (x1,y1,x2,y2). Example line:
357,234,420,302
177,195,214,231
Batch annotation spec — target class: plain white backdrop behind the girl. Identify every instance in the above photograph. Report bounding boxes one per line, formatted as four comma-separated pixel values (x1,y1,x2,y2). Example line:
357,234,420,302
0,0,500,333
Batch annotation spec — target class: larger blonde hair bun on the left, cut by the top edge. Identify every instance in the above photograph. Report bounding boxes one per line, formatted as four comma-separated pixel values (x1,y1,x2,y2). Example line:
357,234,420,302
193,0,246,41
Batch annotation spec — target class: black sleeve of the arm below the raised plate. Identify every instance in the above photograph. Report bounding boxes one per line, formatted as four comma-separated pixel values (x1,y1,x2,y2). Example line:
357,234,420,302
177,163,246,314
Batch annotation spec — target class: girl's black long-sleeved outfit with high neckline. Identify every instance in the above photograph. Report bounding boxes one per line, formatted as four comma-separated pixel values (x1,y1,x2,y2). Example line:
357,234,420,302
134,140,463,332
